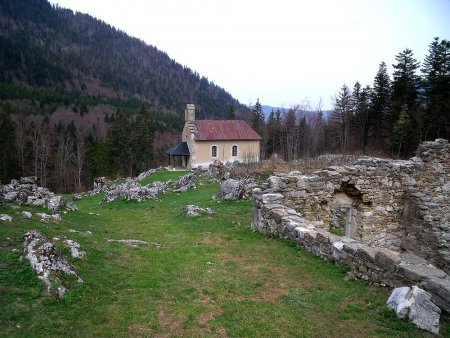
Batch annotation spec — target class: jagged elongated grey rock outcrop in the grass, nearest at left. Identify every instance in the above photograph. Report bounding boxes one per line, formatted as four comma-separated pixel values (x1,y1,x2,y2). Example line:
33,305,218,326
23,231,83,297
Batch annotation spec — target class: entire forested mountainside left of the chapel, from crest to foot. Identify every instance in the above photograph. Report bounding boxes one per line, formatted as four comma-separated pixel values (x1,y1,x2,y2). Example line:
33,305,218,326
0,0,248,191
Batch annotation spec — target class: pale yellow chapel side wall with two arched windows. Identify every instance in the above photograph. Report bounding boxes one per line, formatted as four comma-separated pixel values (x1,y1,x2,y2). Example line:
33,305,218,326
188,141,260,168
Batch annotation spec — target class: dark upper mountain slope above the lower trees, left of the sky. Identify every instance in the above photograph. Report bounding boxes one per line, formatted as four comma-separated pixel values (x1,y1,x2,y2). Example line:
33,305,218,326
0,0,246,118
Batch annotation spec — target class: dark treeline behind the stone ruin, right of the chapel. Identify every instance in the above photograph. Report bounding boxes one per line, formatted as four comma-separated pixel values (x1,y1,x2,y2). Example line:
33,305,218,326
252,38,450,161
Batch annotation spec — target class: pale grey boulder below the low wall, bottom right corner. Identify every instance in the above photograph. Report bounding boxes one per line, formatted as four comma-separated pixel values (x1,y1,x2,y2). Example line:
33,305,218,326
387,286,441,335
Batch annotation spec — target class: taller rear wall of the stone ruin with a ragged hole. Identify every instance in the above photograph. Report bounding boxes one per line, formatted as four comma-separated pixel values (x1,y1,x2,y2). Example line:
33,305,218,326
255,140,450,272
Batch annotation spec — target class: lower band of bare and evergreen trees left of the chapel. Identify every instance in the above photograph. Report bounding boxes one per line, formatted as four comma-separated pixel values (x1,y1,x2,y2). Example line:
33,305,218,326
0,105,172,192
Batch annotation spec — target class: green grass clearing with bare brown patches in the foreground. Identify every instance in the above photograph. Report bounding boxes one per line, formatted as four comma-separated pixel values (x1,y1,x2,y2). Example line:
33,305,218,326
0,176,450,337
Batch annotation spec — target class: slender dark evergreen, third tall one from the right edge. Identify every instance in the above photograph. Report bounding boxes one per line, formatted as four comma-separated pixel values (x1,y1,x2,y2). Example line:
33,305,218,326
369,62,391,150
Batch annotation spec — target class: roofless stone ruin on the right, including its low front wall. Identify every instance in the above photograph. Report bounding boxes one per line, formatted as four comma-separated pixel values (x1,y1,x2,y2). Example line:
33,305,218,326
252,139,450,311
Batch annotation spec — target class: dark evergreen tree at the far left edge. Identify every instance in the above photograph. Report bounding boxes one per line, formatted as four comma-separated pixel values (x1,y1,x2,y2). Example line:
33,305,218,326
0,108,18,183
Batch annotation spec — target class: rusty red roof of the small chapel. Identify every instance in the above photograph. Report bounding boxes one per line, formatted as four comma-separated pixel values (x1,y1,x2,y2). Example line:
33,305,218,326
194,120,261,141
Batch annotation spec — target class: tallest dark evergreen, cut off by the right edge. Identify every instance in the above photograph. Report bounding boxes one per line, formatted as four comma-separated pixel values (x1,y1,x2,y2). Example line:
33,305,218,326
421,37,450,139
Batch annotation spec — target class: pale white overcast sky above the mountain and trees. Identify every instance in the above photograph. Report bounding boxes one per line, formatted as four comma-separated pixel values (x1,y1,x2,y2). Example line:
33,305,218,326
50,0,450,109
